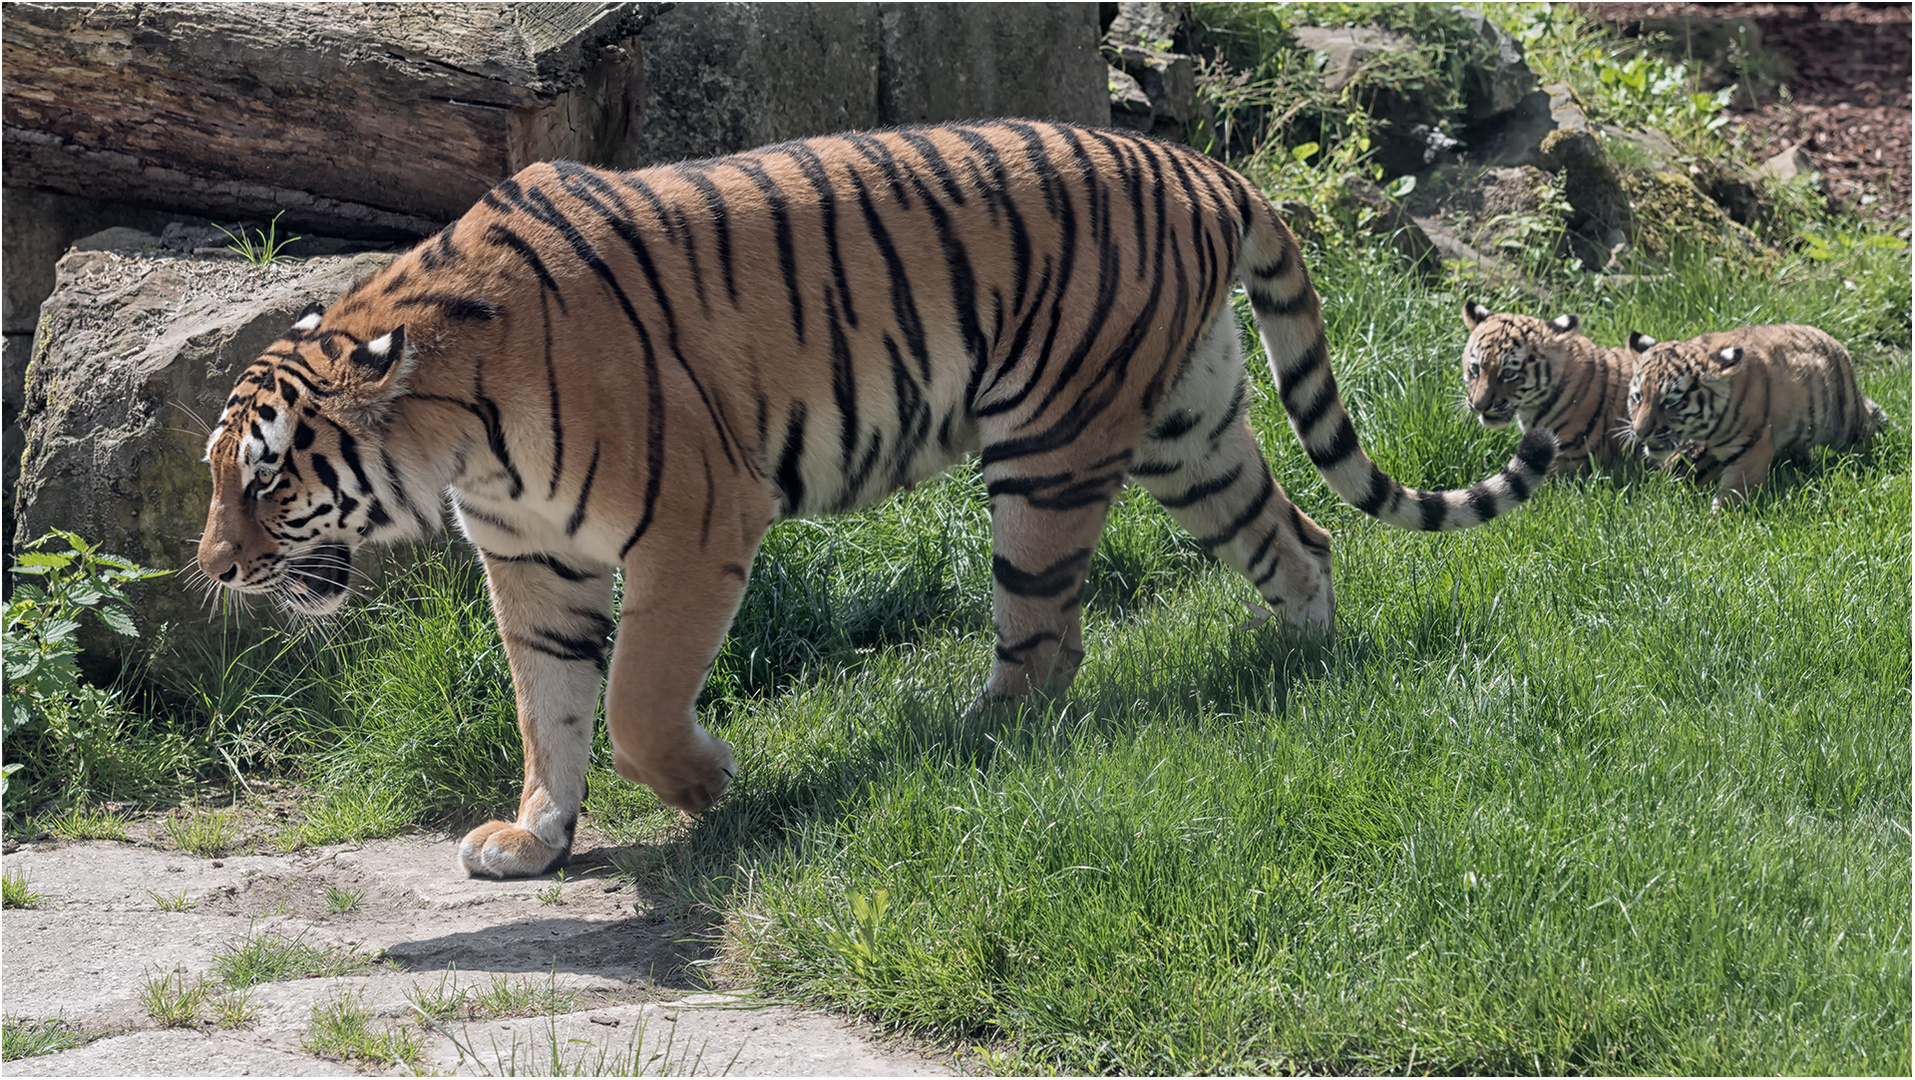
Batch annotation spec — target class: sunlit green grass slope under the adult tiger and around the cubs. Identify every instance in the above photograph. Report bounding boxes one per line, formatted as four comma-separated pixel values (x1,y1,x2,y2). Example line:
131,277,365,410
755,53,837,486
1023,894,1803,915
647,247,1909,1074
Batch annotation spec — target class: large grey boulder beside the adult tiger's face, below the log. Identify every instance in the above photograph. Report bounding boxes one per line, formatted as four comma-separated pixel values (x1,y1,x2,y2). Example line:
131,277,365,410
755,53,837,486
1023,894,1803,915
11,240,391,657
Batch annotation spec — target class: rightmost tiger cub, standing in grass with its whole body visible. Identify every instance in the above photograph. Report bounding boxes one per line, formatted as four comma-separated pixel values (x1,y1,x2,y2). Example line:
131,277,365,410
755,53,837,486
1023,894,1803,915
1628,324,1886,509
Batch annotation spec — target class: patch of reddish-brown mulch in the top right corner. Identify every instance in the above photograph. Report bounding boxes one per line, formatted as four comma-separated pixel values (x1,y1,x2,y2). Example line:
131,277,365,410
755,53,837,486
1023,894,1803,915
1584,4,1915,222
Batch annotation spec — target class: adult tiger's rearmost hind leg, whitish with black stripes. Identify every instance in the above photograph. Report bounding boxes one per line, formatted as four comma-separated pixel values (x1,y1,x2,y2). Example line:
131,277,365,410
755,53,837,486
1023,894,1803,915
1130,308,1337,634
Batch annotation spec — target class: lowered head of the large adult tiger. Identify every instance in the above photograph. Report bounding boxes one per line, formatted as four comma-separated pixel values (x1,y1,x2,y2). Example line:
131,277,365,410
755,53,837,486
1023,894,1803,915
199,304,425,615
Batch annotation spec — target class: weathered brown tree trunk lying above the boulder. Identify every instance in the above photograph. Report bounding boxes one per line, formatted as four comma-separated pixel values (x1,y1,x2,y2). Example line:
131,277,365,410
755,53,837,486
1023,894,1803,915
0,2,672,237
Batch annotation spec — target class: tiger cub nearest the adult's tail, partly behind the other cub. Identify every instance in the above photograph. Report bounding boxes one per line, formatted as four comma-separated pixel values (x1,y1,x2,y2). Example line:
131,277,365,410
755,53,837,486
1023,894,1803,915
1463,301,1635,475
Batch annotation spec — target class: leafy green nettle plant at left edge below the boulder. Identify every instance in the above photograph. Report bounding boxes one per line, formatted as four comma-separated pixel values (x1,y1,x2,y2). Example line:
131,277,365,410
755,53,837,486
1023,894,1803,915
0,530,170,804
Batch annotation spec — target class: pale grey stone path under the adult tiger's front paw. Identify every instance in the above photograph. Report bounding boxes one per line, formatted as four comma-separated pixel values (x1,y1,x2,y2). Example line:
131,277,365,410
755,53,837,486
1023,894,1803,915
0,839,950,1076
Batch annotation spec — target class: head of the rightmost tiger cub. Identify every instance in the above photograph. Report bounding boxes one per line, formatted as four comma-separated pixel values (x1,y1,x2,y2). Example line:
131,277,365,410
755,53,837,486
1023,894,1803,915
1630,331,1743,461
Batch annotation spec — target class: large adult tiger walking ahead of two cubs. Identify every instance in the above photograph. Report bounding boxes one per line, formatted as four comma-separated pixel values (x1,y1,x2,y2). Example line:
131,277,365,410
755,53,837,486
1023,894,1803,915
199,121,1555,877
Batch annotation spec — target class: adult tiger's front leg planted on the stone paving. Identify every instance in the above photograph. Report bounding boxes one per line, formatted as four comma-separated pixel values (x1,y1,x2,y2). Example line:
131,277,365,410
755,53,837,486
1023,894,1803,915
460,551,611,877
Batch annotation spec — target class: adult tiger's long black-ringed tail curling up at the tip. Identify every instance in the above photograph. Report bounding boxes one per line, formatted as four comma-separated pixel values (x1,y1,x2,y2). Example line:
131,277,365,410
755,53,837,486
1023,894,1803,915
1237,191,1557,532
